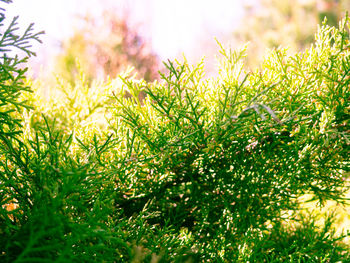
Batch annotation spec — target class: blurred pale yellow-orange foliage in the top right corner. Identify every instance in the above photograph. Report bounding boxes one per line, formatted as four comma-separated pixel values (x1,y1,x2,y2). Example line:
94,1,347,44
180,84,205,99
232,0,350,67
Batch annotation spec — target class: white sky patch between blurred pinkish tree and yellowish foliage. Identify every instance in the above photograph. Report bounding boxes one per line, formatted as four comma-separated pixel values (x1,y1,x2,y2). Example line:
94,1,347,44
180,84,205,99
152,0,243,57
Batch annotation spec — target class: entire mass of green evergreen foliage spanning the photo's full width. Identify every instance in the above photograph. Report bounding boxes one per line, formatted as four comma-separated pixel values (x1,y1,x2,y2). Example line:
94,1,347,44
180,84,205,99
0,1,350,262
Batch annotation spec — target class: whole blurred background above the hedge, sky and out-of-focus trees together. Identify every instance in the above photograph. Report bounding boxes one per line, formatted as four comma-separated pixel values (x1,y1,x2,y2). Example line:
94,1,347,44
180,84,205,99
6,0,350,82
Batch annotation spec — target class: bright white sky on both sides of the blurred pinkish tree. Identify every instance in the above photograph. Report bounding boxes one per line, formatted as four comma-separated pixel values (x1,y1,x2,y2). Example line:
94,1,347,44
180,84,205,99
6,0,249,70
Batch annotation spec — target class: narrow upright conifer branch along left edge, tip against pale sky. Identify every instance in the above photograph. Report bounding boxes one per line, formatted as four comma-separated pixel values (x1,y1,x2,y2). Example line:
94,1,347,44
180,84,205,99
0,1,41,225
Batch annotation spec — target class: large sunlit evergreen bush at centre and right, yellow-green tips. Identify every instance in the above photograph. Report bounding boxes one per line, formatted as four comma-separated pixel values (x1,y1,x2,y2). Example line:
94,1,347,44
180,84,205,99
108,17,350,260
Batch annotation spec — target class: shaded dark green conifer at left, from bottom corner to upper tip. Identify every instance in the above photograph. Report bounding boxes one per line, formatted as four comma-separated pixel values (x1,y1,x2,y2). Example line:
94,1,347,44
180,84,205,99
0,2,130,262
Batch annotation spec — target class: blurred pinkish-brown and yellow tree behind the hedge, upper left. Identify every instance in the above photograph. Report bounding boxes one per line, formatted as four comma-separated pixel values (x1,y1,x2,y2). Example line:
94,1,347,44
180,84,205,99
56,11,159,84
